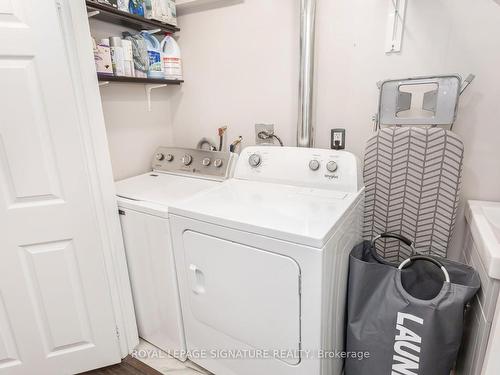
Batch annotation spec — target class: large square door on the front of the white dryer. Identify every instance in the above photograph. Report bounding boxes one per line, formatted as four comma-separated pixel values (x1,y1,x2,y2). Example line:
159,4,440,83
183,231,300,365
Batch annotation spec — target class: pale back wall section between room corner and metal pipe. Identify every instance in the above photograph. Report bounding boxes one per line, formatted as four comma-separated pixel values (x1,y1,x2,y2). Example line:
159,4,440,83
171,0,299,150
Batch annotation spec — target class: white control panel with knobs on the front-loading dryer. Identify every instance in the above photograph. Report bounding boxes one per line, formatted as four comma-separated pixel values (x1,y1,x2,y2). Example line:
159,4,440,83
234,146,363,193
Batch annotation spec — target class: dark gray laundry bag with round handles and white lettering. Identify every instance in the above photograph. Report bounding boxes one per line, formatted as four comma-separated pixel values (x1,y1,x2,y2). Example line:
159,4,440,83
345,233,480,375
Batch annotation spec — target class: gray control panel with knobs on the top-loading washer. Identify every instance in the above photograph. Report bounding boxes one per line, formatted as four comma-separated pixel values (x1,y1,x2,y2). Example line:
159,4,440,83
152,147,237,179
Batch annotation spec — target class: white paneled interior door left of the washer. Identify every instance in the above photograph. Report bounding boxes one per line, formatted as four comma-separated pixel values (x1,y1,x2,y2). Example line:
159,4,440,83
0,0,120,375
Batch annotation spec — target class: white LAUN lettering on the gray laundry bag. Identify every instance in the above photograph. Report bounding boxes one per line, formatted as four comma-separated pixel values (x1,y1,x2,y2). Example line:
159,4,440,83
391,312,424,375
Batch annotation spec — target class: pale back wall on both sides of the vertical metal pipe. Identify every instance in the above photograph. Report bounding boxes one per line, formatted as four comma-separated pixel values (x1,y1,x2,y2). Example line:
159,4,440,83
170,0,500,258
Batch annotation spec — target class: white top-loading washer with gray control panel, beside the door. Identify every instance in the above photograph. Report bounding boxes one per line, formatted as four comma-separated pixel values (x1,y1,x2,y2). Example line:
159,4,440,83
116,147,235,360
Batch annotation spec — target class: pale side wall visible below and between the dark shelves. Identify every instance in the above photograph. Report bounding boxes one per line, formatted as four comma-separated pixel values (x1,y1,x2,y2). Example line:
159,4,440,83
90,19,179,180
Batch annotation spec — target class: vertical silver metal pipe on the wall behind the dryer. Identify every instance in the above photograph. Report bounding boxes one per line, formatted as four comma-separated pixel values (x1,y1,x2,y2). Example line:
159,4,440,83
297,0,316,147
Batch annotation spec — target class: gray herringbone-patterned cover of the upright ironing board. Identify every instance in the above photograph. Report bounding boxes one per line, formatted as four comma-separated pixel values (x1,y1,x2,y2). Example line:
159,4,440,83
363,127,464,262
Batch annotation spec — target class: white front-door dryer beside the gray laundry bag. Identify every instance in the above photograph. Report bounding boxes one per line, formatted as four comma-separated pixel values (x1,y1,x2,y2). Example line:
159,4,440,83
169,147,363,375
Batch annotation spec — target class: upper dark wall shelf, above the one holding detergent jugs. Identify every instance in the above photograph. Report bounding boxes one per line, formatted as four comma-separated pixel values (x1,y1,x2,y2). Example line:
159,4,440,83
85,0,180,33
